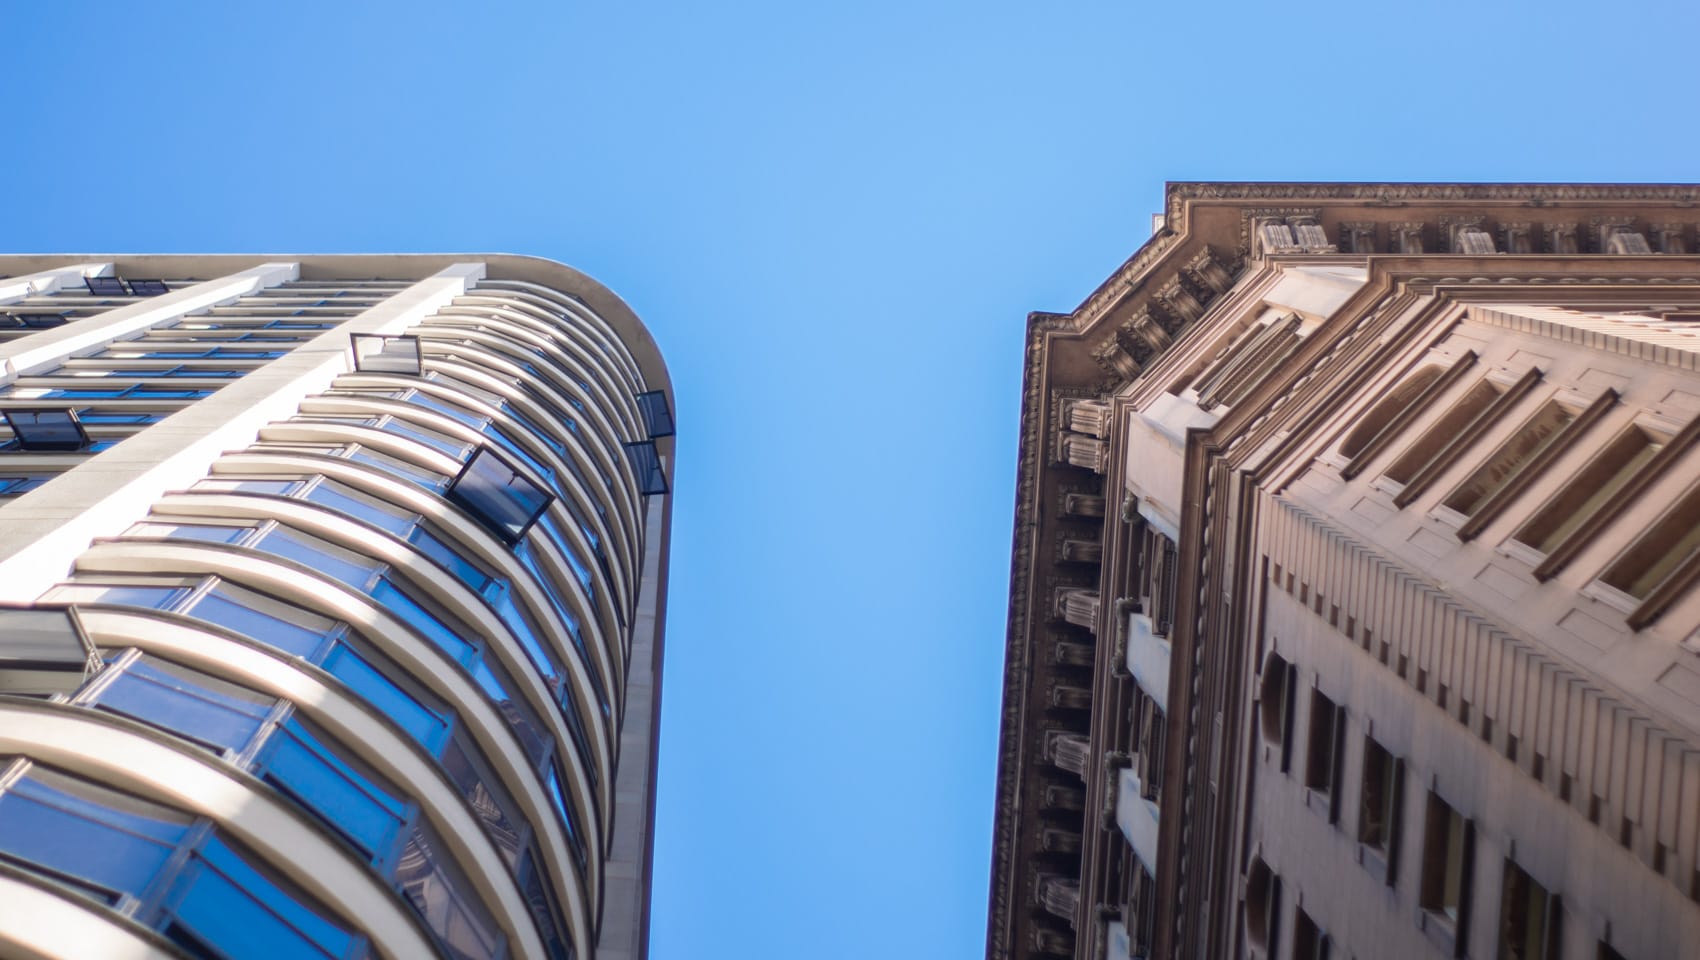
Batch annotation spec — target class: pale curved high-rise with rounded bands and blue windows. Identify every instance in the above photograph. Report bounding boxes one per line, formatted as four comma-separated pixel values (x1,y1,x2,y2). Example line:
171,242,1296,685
0,255,673,960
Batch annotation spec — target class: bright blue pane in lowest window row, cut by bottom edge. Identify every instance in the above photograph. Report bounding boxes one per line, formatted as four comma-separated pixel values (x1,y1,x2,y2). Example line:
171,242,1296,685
167,838,364,958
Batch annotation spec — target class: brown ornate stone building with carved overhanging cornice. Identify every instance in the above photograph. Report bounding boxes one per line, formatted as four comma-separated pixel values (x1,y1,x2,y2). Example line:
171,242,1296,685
988,184,1700,960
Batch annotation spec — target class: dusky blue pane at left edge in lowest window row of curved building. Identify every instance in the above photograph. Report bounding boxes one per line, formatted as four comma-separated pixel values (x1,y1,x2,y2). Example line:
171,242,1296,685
0,765,190,904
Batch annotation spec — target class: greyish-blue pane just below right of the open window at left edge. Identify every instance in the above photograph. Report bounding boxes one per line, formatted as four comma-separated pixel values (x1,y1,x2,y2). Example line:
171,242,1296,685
92,656,277,753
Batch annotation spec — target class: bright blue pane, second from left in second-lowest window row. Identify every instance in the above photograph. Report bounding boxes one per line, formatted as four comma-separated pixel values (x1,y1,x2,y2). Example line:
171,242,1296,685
257,719,408,860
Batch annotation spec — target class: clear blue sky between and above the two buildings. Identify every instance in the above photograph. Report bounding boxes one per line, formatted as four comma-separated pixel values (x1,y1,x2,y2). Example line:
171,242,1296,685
0,0,1700,960
